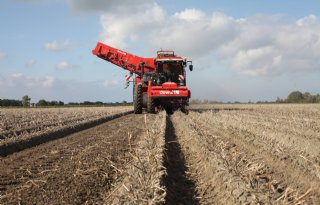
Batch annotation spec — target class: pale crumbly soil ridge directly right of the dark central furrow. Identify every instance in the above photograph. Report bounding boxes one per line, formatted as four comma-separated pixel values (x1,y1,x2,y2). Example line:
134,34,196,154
173,114,255,205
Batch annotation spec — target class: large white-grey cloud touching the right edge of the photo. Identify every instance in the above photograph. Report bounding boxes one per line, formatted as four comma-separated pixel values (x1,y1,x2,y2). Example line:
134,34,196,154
222,15,320,75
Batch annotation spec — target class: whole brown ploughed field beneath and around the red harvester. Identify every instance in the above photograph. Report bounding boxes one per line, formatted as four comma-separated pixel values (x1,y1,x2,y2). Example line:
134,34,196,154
0,105,320,204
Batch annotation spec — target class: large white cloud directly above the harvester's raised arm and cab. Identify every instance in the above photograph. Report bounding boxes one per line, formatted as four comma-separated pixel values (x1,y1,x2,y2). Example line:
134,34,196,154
100,7,238,58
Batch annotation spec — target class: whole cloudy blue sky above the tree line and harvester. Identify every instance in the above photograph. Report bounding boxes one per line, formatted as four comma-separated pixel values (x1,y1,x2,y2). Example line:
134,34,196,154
0,0,320,102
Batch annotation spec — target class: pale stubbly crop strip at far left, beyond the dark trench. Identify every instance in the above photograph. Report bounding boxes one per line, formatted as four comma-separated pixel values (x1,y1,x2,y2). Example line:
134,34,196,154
0,106,132,144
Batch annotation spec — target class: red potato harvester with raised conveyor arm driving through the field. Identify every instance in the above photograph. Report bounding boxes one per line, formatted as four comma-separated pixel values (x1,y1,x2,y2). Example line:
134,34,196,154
92,42,193,114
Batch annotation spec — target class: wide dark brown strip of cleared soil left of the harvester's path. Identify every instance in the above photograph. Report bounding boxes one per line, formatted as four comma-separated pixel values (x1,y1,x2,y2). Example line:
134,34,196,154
0,114,151,204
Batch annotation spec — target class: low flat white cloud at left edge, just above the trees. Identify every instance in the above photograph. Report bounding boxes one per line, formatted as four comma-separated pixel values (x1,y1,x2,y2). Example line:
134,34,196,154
0,73,55,90
